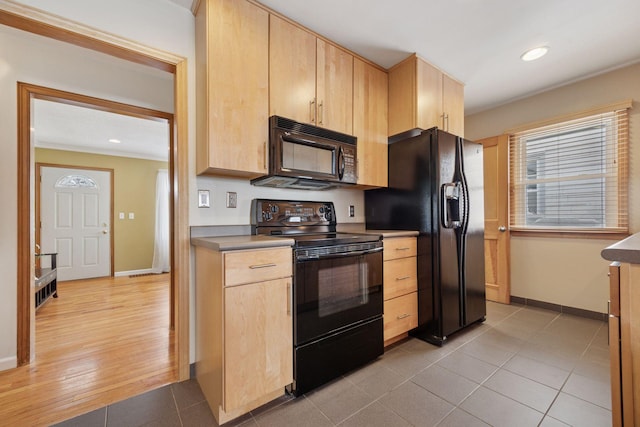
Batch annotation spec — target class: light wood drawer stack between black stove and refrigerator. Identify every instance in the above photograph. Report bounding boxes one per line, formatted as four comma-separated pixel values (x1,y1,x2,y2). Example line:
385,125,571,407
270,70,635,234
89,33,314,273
383,237,418,346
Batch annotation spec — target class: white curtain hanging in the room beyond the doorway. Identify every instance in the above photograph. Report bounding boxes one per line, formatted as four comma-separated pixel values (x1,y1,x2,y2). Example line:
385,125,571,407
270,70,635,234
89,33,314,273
151,169,171,274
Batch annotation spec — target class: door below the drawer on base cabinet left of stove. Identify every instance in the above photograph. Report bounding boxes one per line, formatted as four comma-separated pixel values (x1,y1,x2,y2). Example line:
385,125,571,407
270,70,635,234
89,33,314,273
223,278,293,412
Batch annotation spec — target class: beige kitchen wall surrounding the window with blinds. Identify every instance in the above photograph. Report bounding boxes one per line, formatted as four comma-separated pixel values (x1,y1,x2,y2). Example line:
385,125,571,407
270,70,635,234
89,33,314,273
465,64,640,313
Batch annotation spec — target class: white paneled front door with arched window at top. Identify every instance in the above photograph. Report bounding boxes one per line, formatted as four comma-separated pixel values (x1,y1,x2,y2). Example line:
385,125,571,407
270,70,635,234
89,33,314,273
40,166,111,280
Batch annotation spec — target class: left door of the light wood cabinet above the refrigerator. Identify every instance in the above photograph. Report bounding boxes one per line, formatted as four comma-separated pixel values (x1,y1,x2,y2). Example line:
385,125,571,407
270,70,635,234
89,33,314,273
417,59,444,129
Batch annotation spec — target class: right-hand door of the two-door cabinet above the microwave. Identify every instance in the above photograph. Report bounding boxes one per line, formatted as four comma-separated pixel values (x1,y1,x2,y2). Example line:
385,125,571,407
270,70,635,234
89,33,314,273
316,39,353,135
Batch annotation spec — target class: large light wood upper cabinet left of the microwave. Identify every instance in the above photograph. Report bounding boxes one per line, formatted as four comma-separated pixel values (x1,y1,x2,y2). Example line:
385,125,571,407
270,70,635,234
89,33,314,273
196,0,269,178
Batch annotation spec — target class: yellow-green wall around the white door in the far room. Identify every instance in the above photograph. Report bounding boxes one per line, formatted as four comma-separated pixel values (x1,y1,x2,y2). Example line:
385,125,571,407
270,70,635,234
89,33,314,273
35,148,168,273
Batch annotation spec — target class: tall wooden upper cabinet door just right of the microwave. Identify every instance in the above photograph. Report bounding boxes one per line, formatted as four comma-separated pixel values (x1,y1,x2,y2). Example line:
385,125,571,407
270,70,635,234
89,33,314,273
353,58,388,187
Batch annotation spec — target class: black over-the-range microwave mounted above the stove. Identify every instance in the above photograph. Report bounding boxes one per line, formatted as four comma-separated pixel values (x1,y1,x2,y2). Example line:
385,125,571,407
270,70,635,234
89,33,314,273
251,116,357,190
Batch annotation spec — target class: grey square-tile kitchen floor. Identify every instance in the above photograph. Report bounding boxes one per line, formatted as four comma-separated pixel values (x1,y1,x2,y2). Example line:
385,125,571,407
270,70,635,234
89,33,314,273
53,303,611,427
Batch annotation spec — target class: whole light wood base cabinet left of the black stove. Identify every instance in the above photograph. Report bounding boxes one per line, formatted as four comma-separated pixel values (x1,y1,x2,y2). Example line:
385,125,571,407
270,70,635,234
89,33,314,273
195,246,293,424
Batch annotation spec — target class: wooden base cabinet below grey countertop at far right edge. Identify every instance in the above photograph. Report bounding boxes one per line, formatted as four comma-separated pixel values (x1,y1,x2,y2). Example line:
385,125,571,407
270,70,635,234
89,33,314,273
609,262,640,426
